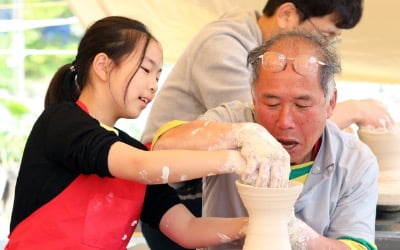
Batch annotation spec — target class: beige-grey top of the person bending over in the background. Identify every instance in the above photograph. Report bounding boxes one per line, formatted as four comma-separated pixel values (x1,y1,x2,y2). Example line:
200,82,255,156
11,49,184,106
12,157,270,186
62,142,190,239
141,9,262,143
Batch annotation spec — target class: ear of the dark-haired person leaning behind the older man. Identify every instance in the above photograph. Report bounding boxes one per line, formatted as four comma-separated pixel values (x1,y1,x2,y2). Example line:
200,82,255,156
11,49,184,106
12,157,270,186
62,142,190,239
275,2,300,29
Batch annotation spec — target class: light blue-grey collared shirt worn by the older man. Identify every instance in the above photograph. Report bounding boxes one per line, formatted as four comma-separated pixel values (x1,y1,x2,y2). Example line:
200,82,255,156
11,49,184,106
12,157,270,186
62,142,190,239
199,101,378,250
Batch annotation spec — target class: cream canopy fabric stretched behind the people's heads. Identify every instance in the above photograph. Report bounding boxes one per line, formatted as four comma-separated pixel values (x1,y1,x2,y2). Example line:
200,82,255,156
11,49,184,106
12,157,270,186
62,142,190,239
68,0,400,83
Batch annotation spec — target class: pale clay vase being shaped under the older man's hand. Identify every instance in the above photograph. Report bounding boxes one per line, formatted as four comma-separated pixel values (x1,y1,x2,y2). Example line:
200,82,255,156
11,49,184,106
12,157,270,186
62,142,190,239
236,181,303,250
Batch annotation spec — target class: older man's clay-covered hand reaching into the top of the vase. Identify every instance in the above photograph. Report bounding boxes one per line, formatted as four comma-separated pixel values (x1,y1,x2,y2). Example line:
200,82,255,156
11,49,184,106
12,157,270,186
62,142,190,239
234,123,290,187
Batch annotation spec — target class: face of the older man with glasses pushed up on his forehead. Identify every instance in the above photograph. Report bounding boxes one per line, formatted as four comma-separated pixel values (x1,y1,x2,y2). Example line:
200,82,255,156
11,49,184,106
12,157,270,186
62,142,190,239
253,41,336,164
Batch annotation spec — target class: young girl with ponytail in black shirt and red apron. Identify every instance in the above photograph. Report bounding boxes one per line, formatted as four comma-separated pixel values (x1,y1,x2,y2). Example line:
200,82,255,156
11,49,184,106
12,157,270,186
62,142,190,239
6,16,246,250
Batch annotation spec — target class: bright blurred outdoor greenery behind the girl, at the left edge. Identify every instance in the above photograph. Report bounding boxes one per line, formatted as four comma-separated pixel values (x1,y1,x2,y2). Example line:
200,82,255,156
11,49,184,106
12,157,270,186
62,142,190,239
0,0,82,166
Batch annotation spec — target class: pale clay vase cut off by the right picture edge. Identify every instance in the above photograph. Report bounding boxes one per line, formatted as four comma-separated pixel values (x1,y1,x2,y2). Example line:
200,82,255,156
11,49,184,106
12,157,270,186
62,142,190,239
358,123,400,206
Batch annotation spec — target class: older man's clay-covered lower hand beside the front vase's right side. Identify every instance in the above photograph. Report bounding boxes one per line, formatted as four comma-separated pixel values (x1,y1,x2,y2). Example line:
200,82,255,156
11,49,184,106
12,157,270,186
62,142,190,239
288,211,319,250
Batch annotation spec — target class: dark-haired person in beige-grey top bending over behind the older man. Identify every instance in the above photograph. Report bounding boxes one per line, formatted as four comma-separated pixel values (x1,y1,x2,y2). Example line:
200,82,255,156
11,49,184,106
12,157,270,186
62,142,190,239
141,0,394,250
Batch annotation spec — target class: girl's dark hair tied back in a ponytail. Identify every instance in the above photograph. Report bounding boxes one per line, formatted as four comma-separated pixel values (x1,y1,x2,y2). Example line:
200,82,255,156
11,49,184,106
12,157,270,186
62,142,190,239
44,16,156,107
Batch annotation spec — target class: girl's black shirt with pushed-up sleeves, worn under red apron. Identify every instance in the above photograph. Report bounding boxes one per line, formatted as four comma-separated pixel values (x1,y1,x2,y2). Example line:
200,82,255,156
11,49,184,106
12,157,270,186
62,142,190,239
10,103,180,232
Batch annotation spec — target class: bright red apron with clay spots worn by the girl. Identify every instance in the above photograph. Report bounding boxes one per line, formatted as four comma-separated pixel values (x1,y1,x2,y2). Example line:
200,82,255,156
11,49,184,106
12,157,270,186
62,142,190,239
5,175,146,250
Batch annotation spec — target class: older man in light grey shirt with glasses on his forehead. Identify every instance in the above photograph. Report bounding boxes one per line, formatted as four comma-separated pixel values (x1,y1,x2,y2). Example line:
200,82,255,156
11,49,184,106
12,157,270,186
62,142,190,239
153,30,378,249
